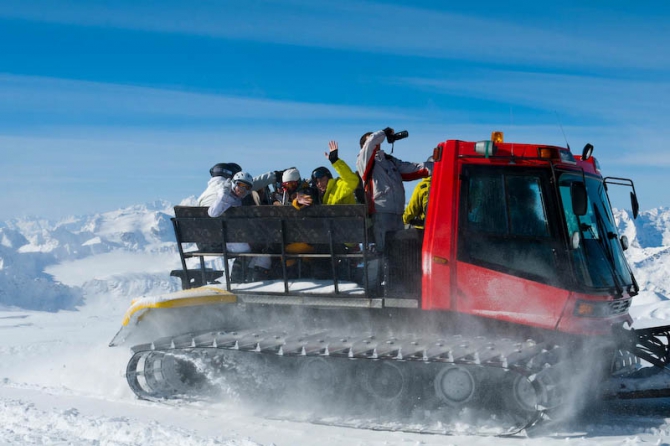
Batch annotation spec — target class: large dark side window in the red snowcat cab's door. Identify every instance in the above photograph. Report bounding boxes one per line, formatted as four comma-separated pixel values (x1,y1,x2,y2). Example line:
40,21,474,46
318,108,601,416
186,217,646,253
458,166,556,282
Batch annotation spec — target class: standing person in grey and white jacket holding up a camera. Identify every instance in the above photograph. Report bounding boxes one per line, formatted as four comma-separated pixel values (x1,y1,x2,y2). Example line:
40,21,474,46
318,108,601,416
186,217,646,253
356,127,433,252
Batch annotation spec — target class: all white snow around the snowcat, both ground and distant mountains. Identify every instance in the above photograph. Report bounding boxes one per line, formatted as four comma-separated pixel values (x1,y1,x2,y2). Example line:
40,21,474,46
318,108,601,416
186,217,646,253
0,202,670,446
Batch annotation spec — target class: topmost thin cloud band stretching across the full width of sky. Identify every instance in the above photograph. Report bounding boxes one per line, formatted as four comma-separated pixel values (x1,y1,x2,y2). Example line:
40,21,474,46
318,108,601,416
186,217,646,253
0,0,670,69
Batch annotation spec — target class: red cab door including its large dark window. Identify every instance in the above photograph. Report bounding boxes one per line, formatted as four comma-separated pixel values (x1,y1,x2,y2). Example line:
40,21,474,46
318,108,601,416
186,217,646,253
452,165,569,329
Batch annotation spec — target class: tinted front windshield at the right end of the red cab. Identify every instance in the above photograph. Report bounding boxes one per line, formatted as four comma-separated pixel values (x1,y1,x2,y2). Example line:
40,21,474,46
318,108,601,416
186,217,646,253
559,173,637,295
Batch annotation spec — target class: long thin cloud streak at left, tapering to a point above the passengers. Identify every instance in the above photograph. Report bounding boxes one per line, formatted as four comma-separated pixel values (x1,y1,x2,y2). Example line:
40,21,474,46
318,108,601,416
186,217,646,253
0,74,408,120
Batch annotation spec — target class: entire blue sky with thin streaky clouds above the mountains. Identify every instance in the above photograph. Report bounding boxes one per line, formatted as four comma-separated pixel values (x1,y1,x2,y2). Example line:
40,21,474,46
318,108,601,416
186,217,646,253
0,0,670,220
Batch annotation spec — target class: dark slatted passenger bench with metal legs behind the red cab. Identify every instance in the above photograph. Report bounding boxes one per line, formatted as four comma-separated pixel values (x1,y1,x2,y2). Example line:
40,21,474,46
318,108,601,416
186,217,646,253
172,205,369,294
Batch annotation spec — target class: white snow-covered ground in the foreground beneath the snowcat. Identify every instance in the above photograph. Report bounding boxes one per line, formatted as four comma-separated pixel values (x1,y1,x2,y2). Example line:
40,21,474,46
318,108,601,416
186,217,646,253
5,296,670,446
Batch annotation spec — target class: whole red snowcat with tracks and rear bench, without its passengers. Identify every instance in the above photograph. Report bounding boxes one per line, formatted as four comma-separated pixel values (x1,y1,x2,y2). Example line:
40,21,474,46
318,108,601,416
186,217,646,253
110,132,670,435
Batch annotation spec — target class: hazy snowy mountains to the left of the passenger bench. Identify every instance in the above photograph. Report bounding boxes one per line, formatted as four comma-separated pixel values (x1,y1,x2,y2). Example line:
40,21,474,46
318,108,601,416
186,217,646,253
0,198,194,311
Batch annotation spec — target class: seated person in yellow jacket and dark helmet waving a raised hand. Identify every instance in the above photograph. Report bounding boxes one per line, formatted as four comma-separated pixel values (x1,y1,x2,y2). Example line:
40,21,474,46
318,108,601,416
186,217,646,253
293,141,359,209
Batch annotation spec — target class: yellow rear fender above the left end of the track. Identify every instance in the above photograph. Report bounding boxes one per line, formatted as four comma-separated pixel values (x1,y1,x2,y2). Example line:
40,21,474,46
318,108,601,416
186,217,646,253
109,286,237,346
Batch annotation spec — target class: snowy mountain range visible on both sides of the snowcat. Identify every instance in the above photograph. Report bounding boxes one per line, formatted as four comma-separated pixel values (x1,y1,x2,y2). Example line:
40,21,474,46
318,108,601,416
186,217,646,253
0,197,670,311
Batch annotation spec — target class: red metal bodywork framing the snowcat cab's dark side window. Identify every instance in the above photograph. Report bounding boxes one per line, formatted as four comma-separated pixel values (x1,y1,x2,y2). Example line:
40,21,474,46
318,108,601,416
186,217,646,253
422,140,630,335
